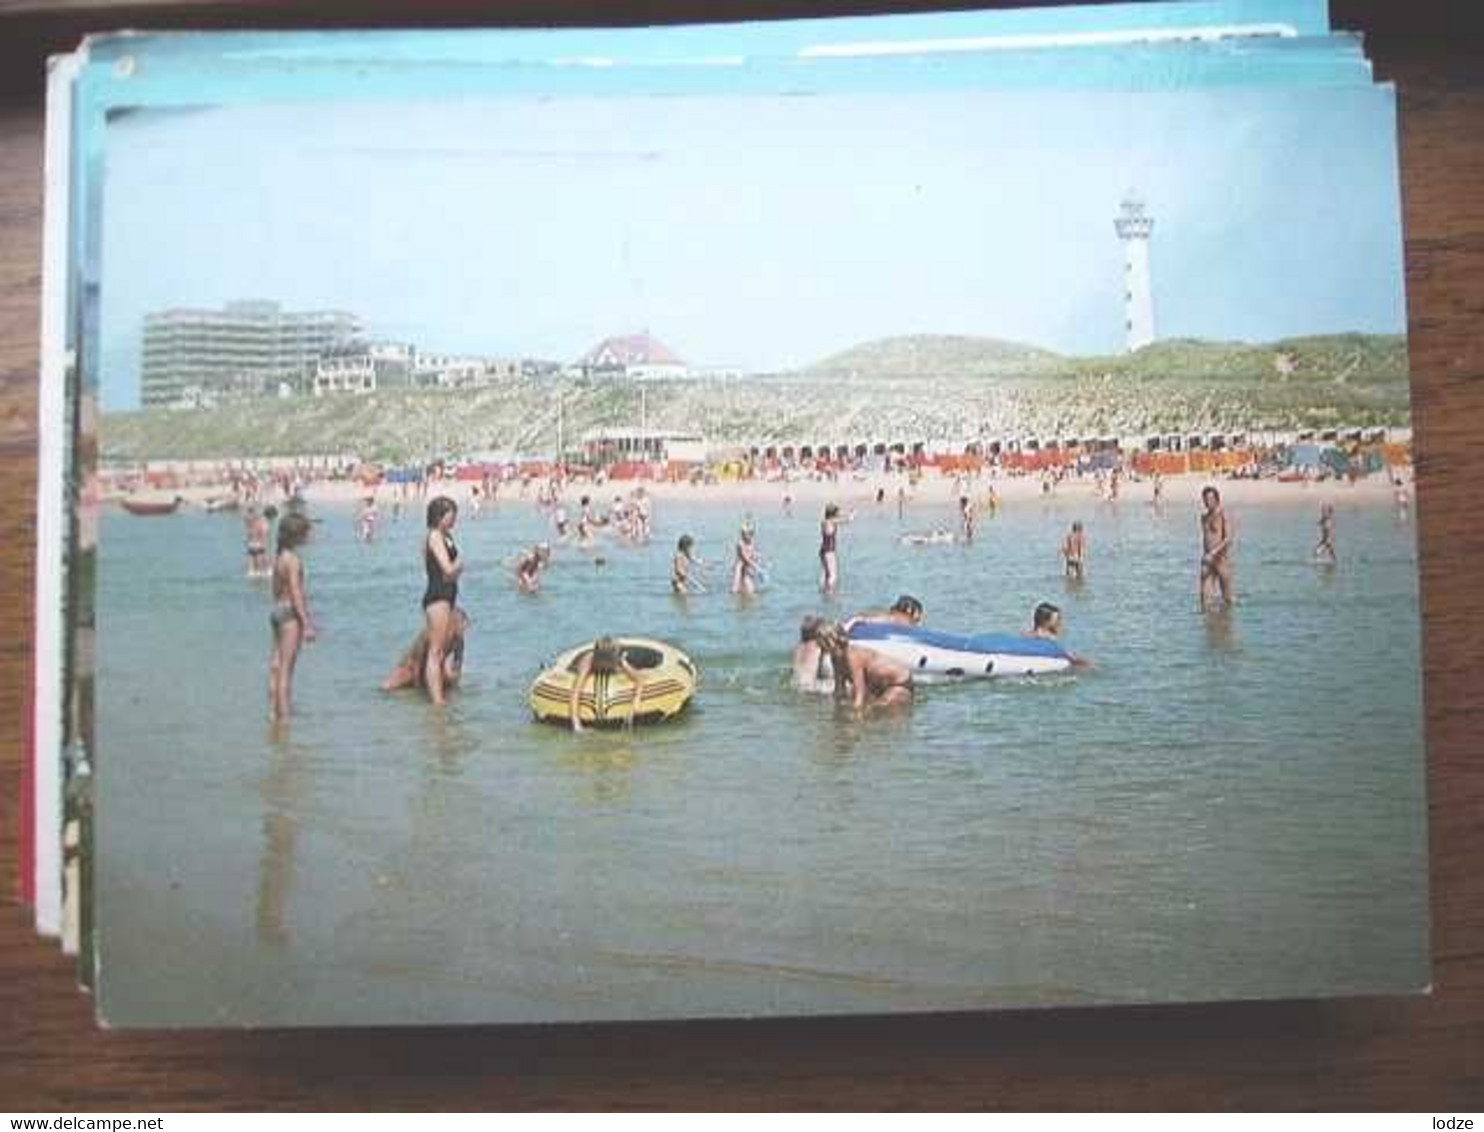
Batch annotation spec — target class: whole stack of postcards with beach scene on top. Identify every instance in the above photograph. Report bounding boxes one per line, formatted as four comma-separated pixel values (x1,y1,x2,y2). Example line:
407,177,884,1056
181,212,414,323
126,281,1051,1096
22,0,1429,1027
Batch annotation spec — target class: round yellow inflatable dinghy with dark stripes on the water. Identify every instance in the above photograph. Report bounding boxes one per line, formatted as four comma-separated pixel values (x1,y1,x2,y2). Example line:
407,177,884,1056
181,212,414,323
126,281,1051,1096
530,636,696,727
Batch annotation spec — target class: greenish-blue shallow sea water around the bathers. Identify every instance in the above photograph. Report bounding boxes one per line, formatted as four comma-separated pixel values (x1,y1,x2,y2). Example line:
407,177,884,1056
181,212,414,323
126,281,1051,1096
96,490,1428,1025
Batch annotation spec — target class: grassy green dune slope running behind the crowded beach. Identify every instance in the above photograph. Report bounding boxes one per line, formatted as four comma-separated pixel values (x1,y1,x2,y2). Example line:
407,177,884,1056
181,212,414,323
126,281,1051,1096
101,334,1410,463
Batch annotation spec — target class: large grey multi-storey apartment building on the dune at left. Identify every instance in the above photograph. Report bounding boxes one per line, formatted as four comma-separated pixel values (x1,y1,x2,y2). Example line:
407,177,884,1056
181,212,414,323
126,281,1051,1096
139,301,361,408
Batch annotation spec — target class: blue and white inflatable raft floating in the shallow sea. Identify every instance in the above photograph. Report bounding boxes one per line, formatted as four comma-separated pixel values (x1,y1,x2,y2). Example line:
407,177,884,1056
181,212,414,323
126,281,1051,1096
850,622,1071,679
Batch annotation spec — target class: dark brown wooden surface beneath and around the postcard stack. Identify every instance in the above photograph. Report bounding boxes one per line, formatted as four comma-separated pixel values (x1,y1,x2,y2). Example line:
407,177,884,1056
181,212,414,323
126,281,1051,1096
0,0,1484,1113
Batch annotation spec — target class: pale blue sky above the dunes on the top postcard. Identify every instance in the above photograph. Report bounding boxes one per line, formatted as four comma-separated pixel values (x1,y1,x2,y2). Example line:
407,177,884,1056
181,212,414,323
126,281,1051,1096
102,88,1405,408
